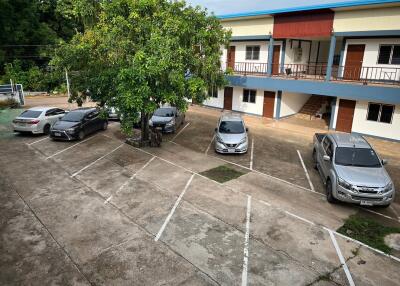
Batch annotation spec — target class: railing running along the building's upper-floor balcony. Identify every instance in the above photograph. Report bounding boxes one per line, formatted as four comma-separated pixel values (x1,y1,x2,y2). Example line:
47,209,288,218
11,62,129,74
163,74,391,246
226,62,400,87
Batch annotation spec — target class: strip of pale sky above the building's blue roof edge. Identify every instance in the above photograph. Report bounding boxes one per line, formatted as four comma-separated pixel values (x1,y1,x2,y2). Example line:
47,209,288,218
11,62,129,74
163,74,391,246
186,0,364,16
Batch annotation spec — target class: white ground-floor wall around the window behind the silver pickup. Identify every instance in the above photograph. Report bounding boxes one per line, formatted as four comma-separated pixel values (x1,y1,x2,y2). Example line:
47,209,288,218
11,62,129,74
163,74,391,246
352,101,400,140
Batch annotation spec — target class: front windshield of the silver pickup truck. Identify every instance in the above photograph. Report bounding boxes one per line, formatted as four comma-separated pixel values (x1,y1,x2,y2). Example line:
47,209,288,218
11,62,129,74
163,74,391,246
335,147,381,168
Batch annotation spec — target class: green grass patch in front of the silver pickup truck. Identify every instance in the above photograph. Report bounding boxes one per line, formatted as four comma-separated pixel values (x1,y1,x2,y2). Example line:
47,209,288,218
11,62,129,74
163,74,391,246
337,214,400,253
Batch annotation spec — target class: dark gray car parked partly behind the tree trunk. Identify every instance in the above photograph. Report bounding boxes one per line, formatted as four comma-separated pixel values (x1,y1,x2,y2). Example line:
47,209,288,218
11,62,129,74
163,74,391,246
149,106,185,133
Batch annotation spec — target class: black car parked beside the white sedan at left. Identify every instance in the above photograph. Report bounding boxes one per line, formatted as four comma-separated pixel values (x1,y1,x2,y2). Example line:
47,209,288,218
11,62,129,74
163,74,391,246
50,108,108,140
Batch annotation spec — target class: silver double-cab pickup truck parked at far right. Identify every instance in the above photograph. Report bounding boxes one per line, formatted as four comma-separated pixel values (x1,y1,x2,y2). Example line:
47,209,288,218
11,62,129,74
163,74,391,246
313,133,395,207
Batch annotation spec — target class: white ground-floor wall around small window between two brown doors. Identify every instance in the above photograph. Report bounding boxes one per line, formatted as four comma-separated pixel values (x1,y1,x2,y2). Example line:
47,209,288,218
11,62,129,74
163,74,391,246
232,87,264,115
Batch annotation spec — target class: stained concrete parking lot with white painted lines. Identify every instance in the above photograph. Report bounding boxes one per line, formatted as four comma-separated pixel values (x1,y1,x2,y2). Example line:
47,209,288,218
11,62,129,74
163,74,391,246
0,99,400,285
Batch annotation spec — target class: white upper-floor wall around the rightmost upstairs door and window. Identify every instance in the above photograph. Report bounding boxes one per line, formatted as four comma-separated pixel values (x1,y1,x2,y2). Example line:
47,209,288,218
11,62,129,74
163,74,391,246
342,38,400,80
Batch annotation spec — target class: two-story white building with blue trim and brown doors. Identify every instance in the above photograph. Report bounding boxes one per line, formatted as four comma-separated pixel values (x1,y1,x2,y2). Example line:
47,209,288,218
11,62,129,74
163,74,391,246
204,0,400,140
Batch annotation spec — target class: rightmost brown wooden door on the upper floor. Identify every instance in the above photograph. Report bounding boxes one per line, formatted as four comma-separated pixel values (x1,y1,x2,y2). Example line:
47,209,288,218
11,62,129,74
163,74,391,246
343,45,365,80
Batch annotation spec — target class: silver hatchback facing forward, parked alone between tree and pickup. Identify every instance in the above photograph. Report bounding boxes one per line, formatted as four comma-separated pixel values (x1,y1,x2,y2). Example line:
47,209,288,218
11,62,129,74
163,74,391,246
215,114,249,154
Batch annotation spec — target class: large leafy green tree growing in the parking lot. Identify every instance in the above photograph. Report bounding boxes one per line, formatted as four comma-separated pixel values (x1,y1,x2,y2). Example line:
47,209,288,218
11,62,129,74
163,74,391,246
53,0,230,140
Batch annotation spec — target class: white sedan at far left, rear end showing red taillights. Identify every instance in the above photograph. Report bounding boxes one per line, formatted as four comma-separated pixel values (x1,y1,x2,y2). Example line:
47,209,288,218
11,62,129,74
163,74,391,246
12,107,65,134
